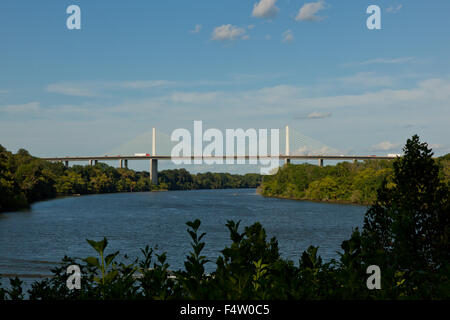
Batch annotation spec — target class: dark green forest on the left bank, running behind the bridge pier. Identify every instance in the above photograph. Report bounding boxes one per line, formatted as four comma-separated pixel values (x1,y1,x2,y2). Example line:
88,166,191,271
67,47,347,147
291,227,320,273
0,145,262,212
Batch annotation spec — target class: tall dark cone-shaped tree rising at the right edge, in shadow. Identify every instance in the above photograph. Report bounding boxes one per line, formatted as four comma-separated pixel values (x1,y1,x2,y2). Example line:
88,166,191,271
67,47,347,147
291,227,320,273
362,135,450,271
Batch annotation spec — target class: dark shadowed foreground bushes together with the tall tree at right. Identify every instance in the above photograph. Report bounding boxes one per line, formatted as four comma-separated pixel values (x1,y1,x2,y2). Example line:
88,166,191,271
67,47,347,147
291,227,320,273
0,136,450,300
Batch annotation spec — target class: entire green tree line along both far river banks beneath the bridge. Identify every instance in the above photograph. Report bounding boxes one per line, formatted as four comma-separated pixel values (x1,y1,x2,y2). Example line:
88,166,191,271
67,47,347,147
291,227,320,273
0,145,450,213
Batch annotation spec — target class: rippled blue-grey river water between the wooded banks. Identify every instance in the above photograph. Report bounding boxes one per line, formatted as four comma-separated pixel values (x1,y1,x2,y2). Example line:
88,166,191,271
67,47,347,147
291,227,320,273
0,189,366,279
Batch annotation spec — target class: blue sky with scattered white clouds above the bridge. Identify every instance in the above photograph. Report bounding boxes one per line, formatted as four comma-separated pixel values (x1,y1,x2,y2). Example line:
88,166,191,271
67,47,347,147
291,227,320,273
0,0,450,172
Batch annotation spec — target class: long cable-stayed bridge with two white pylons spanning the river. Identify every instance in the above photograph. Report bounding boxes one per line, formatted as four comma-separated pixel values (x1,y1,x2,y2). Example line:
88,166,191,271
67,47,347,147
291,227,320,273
41,126,395,184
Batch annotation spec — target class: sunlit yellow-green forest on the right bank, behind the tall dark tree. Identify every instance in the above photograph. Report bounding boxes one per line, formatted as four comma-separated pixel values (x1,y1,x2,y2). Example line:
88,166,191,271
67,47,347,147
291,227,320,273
261,154,450,205
